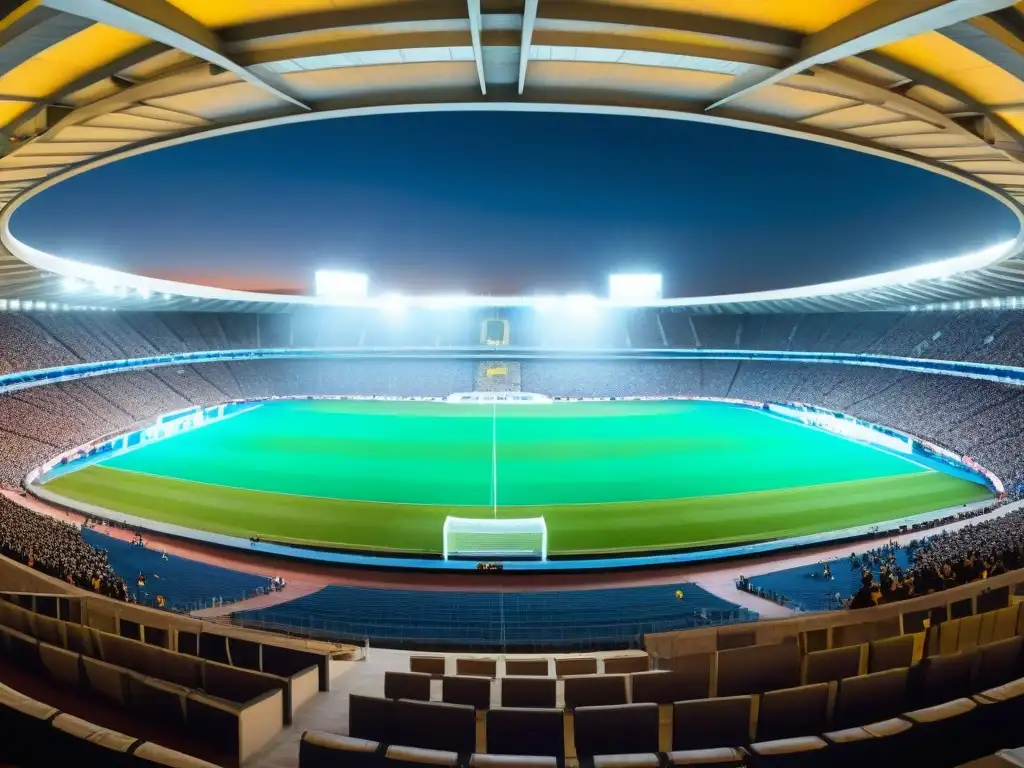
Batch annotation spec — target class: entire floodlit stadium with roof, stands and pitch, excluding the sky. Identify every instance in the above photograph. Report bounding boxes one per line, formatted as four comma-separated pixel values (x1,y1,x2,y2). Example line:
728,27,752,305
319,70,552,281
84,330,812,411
0,0,1024,768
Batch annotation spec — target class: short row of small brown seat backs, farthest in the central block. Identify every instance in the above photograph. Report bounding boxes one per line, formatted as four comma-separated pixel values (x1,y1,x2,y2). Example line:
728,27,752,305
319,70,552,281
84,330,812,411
409,653,650,678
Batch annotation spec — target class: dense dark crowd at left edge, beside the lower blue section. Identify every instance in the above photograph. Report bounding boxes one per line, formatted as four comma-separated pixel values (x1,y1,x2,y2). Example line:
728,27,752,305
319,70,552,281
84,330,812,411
0,497,129,600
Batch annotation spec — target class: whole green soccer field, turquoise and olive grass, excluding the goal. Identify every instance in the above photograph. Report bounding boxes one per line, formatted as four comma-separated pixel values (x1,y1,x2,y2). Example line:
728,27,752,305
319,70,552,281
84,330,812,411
46,400,990,555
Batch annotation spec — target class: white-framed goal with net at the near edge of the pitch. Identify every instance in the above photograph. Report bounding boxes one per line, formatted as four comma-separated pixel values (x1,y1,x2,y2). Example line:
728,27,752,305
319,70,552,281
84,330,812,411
443,517,548,560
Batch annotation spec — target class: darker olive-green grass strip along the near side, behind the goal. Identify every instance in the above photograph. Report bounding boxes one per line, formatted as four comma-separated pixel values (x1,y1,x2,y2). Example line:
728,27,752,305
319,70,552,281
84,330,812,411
47,466,989,554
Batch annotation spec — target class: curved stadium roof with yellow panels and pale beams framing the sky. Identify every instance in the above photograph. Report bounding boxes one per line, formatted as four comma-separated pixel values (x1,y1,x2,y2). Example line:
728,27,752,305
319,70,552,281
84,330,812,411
0,0,1024,311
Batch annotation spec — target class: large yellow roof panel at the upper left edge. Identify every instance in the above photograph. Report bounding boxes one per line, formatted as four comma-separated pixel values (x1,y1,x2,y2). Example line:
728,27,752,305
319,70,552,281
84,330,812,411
0,24,150,112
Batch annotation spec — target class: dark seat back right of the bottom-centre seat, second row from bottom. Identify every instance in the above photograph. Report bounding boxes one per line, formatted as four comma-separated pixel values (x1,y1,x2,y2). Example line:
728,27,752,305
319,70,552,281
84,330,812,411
573,703,658,758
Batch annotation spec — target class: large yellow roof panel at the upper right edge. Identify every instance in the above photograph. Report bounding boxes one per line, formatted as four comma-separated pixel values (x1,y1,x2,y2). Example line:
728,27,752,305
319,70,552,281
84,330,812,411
879,32,1024,104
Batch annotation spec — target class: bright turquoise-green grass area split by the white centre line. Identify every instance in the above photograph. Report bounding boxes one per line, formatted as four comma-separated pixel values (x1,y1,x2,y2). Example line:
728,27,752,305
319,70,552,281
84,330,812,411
94,401,926,507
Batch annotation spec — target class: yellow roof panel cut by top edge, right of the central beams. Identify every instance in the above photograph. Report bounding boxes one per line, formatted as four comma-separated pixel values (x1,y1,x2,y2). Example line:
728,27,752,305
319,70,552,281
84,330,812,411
585,0,872,34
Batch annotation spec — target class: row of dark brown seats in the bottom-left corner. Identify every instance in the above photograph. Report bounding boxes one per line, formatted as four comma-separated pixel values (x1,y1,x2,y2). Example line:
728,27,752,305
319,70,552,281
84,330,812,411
0,685,215,768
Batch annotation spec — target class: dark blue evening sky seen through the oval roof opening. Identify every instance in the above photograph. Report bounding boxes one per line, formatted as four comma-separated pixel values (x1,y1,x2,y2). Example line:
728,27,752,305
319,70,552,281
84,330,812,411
12,113,1017,295
